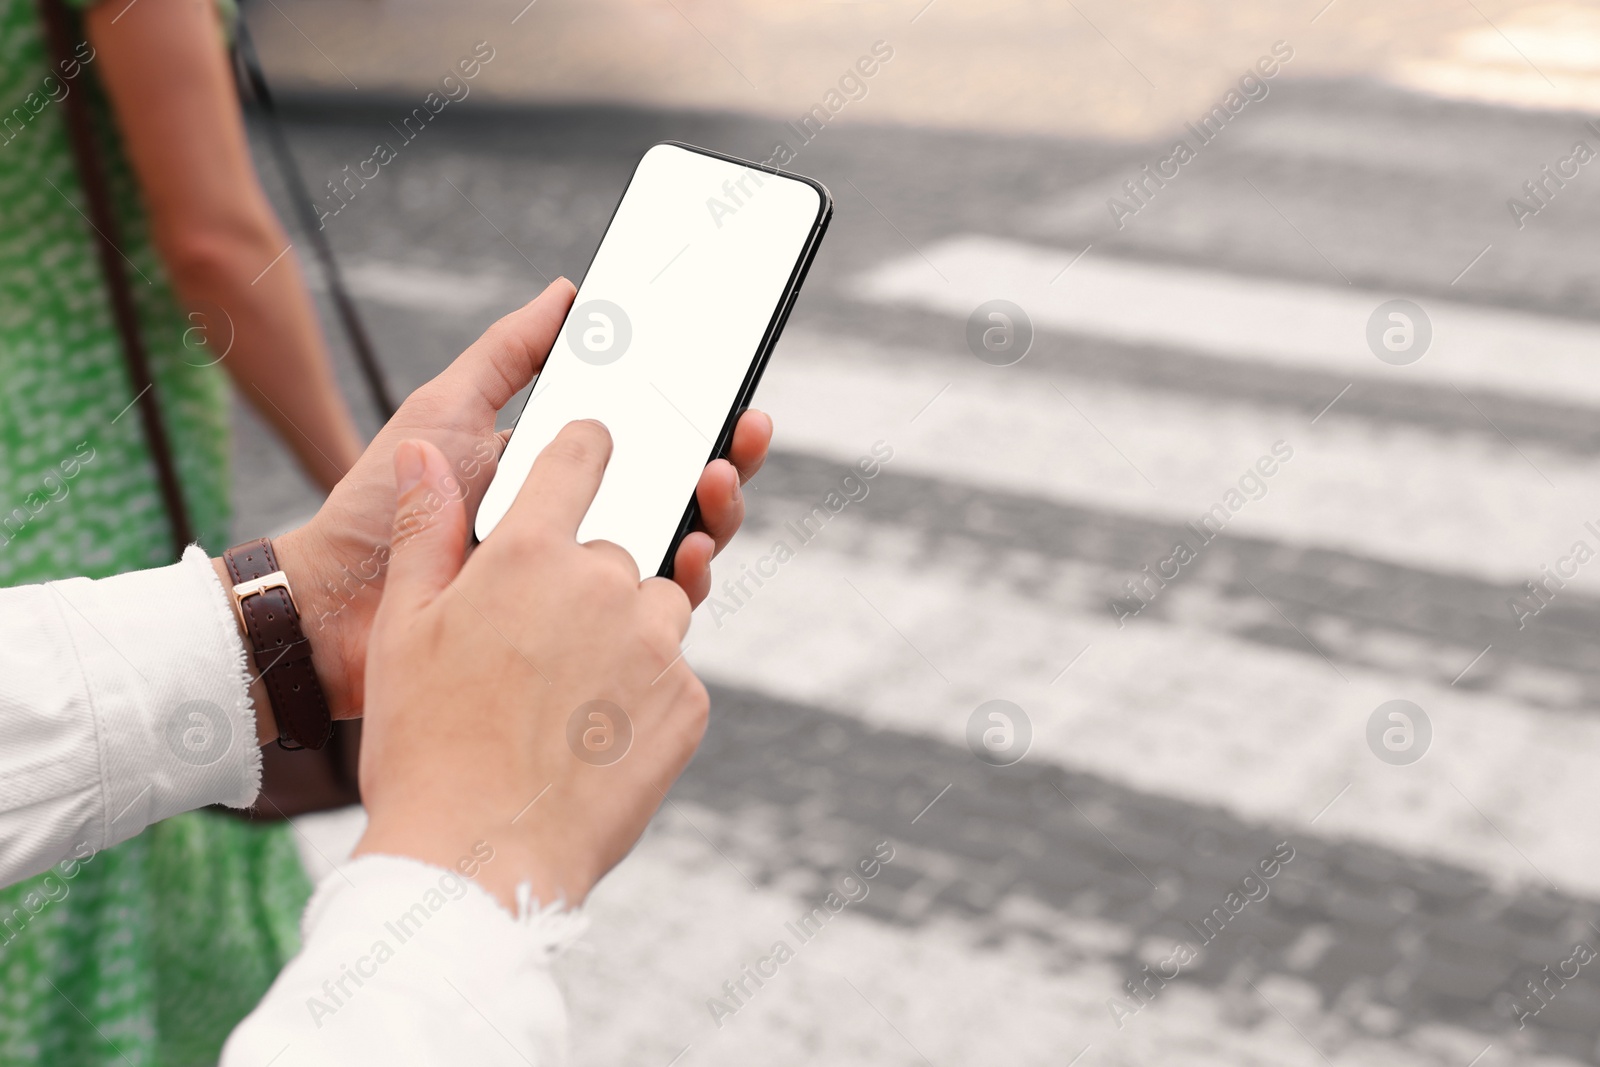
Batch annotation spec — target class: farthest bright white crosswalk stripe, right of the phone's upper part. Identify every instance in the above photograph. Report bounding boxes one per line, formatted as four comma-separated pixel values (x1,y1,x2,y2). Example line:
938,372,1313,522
846,235,1600,405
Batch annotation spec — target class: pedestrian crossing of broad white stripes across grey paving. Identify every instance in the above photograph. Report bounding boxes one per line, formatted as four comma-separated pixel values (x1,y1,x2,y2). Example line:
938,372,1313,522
265,102,1600,1067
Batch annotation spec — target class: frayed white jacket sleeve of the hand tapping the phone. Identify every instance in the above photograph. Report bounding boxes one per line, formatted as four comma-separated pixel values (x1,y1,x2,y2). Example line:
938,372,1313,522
222,845,586,1067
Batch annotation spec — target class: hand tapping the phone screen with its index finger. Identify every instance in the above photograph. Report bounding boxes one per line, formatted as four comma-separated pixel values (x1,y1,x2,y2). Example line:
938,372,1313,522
355,422,707,907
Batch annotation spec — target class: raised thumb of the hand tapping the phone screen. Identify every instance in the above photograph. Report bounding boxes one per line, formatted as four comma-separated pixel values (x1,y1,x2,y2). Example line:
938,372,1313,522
384,440,467,603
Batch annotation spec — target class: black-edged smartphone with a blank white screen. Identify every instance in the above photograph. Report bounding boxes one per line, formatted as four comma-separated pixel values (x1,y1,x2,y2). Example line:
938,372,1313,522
474,141,834,577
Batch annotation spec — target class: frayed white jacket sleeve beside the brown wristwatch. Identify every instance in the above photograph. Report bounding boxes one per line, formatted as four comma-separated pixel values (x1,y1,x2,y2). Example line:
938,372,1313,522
0,549,261,885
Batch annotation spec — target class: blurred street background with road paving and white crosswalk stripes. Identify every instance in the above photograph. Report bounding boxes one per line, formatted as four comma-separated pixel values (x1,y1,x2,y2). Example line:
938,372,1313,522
237,0,1600,1067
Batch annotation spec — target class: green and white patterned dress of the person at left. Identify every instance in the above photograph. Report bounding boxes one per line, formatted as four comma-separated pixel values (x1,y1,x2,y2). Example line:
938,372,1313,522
0,0,309,1067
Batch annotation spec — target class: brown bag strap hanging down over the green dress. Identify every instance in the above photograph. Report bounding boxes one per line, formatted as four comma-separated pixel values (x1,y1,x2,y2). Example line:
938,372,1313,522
38,0,194,560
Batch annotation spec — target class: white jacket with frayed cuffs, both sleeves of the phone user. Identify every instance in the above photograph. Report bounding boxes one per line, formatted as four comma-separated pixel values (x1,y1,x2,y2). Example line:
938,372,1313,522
0,547,584,1067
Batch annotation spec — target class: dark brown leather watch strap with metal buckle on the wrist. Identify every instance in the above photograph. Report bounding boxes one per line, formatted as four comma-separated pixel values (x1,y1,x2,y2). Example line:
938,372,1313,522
222,537,333,749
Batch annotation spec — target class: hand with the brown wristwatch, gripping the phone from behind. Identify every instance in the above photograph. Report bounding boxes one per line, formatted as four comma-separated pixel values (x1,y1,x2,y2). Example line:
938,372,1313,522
260,278,773,735
